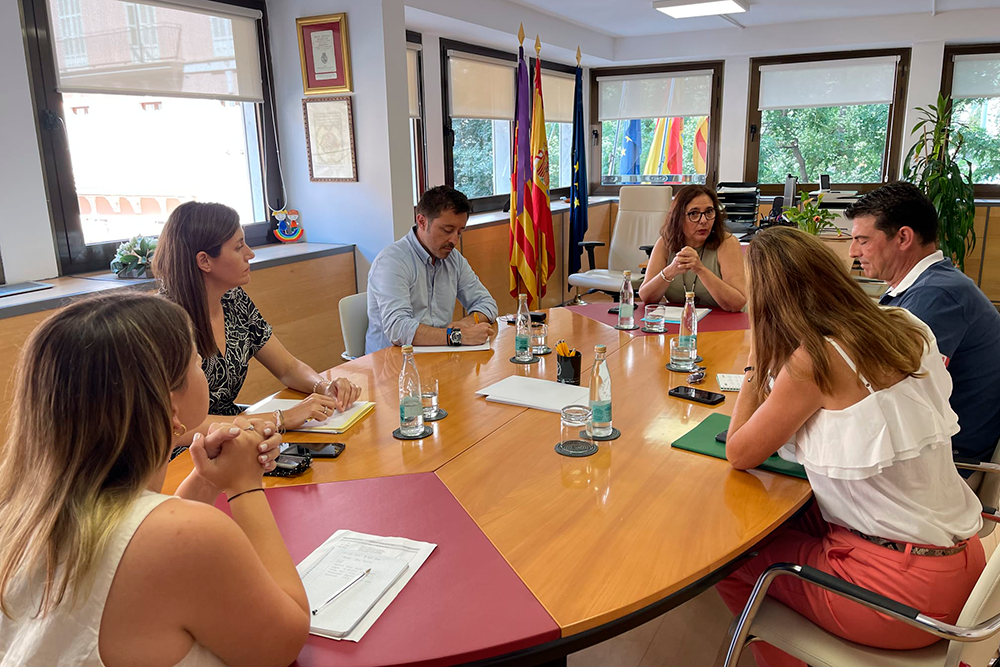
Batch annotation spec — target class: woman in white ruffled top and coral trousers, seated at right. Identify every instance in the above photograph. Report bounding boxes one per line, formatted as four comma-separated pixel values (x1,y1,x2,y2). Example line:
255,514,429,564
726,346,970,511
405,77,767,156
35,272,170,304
718,227,985,667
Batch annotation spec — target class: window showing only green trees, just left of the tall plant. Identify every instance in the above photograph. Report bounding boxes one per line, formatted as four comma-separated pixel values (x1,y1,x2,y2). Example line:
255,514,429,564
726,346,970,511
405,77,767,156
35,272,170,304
744,49,909,194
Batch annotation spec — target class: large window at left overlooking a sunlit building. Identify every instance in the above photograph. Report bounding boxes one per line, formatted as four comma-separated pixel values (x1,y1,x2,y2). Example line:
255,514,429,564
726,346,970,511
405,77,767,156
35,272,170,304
25,0,283,274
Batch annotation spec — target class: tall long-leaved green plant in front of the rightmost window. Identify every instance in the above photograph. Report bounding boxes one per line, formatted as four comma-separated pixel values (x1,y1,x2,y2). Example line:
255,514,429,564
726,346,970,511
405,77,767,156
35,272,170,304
904,95,976,271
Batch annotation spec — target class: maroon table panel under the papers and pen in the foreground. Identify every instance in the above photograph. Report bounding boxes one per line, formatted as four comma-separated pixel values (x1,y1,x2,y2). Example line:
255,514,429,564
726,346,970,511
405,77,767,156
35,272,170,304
219,473,560,667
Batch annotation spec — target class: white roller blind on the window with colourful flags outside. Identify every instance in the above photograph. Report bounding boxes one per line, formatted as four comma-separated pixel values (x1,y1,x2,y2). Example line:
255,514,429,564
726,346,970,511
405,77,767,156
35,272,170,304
597,72,712,121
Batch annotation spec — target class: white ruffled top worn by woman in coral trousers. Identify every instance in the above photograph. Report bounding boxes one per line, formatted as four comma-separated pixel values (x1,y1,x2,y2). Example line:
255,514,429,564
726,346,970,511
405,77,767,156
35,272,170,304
795,311,982,547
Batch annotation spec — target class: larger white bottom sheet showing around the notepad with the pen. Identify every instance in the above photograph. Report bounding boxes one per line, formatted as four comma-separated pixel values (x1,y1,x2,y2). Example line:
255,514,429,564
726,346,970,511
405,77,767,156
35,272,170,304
296,530,437,642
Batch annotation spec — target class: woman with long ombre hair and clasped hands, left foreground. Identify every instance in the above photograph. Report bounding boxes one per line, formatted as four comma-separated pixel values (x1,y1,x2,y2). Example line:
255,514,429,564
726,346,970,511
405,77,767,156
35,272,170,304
0,292,309,667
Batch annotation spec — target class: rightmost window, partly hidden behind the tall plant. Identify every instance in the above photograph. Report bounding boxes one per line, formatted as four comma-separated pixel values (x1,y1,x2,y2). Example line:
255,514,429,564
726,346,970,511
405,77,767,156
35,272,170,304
942,44,1000,196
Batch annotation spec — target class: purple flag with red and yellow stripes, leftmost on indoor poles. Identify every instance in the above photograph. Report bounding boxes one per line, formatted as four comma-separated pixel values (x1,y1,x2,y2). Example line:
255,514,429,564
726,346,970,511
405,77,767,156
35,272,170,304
509,46,538,306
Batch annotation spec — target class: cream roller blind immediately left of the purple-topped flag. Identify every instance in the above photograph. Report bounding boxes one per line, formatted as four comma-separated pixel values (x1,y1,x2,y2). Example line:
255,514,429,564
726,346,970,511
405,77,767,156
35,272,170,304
448,51,516,120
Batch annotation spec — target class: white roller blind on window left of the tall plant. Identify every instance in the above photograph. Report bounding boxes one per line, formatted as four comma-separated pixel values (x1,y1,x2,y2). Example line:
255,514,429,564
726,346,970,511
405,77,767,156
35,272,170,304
759,56,899,111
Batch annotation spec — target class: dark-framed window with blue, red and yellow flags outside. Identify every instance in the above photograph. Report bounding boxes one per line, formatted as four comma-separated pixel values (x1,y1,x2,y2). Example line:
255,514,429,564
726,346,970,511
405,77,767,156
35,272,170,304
592,63,722,193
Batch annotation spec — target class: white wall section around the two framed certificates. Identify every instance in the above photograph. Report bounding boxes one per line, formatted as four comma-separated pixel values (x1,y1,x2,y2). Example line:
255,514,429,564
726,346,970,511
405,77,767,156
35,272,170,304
268,0,413,289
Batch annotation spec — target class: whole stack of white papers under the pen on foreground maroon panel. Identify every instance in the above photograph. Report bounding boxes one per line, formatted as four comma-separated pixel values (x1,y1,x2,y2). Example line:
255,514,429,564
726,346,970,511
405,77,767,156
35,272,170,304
297,530,437,642
